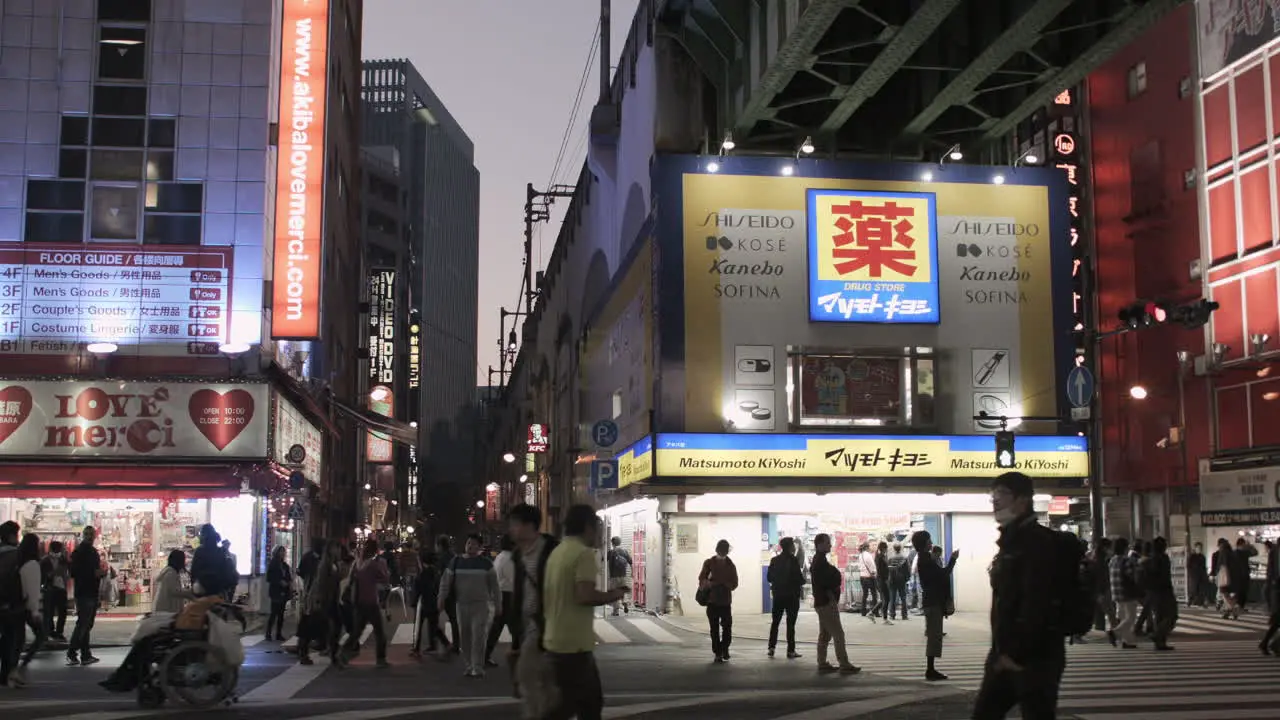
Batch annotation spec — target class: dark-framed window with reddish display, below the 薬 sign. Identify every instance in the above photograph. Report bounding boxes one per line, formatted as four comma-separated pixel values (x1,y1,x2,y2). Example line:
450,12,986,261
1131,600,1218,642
783,348,936,429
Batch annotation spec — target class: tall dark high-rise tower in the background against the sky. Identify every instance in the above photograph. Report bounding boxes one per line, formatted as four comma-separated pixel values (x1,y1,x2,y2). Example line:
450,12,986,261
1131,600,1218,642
362,60,480,515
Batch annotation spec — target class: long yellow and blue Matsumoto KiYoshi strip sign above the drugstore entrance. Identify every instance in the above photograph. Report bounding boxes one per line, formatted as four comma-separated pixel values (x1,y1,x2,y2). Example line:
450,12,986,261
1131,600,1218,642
650,433,1089,484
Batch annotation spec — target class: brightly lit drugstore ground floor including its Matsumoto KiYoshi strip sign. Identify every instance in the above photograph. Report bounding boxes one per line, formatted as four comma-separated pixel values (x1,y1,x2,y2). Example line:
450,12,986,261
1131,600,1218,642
604,433,1088,614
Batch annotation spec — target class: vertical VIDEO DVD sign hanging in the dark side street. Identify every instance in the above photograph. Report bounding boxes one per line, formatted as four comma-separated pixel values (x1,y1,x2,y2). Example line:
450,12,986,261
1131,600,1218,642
365,268,396,462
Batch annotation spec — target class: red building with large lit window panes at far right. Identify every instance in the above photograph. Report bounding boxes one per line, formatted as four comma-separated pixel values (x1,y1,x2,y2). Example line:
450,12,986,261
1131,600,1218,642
1089,4,1280,544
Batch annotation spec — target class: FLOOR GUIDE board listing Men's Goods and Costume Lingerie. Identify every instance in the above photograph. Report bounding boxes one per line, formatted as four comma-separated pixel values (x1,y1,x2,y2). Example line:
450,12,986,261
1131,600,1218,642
0,243,235,355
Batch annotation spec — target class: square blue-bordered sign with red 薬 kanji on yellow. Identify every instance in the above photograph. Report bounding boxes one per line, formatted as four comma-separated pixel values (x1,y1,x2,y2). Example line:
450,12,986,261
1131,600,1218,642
808,190,938,323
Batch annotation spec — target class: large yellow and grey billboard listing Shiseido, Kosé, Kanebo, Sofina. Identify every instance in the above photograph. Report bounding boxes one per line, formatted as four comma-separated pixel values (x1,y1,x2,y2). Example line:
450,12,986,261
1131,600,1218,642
659,158,1071,435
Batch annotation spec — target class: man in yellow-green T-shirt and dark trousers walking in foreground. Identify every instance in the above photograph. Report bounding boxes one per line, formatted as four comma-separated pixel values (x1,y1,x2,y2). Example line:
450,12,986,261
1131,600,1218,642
543,505,630,720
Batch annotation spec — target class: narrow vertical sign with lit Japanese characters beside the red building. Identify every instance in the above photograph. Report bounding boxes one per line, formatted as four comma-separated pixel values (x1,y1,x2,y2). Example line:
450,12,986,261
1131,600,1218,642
1044,88,1092,365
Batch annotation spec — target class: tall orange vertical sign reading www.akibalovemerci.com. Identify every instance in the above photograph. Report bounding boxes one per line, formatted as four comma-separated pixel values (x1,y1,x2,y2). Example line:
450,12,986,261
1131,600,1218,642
271,0,329,340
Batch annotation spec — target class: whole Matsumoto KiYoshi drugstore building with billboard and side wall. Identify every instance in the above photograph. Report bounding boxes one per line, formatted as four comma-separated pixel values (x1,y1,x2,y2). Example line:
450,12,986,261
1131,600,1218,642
485,3,1088,612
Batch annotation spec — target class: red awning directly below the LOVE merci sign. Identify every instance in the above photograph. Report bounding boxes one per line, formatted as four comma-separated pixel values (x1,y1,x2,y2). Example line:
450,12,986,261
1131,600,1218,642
0,462,243,500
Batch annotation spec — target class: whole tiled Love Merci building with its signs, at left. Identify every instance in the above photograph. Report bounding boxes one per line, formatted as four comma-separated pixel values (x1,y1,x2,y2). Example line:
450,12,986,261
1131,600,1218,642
0,0,361,605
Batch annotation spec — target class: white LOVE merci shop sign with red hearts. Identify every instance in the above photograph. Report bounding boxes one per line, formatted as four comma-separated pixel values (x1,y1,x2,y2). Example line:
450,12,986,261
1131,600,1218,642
0,380,270,460
